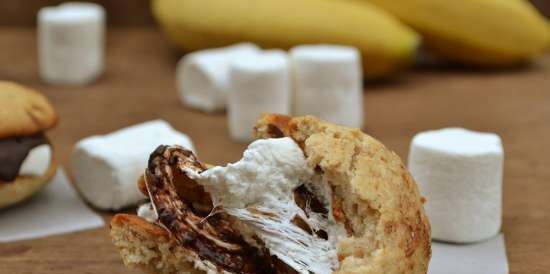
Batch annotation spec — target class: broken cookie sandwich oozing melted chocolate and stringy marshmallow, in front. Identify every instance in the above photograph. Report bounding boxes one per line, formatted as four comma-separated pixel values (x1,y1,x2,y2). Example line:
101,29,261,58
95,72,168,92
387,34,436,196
111,114,431,274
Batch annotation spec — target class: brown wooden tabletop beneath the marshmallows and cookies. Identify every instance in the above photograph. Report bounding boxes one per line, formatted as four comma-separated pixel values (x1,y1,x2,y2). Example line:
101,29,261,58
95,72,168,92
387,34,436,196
0,28,550,274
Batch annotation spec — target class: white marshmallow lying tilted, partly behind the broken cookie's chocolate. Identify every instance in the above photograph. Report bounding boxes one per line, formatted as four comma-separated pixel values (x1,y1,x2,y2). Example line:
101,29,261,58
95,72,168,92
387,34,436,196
71,120,194,210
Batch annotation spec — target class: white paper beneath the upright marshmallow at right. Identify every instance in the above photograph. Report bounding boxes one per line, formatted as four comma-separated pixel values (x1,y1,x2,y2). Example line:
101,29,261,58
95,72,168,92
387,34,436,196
428,234,508,274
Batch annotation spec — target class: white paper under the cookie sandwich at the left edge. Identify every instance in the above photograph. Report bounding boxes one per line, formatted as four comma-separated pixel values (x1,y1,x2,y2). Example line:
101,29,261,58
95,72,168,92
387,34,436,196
0,168,105,242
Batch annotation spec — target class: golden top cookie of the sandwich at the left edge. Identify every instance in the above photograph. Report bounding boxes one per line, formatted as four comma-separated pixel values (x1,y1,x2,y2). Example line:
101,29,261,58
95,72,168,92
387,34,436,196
0,81,58,138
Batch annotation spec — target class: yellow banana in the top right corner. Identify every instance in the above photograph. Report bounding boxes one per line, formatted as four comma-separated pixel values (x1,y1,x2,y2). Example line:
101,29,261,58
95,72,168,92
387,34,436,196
366,0,550,66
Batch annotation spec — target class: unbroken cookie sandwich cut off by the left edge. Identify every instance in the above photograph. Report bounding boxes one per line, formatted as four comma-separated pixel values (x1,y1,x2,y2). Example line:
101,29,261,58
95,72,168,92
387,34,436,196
0,81,58,208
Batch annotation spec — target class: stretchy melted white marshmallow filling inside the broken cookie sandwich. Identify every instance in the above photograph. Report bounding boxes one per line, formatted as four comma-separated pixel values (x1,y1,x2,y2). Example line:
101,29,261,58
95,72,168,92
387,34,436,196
188,137,346,274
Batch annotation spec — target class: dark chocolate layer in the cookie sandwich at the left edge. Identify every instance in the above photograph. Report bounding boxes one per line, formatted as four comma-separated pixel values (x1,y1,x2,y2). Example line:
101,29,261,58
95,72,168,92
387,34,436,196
0,132,48,182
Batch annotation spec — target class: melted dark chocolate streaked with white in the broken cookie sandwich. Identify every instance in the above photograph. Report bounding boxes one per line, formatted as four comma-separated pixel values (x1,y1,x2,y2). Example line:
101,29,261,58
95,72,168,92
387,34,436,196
145,146,280,274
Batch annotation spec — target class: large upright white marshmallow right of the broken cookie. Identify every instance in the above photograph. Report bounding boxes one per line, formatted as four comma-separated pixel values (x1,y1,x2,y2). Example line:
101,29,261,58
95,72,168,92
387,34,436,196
409,128,503,243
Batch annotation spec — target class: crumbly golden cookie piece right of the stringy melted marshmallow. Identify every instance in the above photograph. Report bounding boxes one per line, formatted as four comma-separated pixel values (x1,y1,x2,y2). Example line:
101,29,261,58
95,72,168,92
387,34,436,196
255,114,431,274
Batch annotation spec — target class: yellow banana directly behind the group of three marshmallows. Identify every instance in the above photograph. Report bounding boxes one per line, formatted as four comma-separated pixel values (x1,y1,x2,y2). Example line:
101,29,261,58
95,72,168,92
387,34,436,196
152,0,420,78
